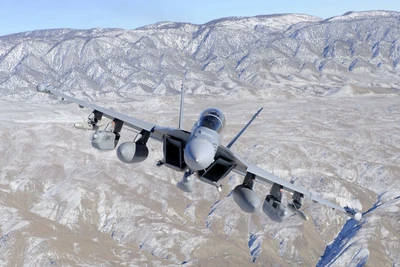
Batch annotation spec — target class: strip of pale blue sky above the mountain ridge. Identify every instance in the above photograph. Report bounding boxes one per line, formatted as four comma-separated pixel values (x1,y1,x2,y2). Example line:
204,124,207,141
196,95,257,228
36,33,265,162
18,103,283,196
0,0,400,36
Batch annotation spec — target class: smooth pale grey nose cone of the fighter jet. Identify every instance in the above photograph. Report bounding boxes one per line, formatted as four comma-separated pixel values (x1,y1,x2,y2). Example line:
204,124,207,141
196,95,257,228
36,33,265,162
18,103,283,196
184,138,215,171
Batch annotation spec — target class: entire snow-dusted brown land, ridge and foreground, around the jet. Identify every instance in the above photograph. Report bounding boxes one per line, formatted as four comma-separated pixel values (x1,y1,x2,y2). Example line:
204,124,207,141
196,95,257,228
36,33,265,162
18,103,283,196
0,11,400,266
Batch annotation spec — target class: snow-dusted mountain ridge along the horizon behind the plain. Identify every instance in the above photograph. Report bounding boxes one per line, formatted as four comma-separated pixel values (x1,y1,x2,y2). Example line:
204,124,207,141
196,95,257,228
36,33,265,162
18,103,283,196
0,11,400,99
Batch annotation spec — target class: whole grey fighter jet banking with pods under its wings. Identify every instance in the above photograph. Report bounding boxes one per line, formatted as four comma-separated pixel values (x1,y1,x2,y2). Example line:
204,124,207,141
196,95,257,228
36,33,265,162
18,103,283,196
37,84,362,222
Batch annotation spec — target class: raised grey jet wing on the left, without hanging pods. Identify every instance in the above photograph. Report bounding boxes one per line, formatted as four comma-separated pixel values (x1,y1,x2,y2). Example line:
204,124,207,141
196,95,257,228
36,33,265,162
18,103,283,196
37,84,190,142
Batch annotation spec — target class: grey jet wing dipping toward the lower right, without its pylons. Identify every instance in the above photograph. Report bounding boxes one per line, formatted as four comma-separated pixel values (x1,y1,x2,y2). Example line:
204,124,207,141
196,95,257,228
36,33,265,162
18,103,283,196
222,146,362,221
